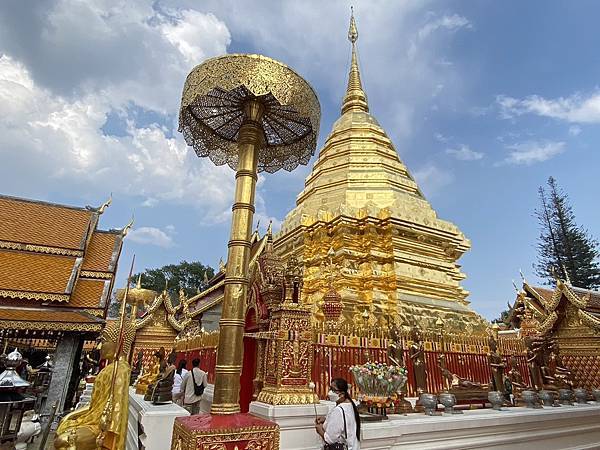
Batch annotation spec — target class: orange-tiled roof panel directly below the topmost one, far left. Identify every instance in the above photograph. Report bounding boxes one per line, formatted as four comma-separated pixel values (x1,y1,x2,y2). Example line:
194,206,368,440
0,250,76,294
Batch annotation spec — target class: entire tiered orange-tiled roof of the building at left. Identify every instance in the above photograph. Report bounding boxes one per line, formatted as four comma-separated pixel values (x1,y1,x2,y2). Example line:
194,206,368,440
0,196,126,339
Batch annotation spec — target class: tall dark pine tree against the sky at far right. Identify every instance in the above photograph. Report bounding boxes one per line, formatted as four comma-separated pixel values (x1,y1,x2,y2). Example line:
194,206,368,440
534,177,600,289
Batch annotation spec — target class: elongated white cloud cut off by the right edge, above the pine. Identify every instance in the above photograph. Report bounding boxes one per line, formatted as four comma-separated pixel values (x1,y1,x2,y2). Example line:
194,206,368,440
496,91,600,123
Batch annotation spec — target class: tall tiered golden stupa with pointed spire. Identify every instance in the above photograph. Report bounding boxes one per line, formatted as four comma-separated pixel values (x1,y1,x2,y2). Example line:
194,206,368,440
275,10,486,334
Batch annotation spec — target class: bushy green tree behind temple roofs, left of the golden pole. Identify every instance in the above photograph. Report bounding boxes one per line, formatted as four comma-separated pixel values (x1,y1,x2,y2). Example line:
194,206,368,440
108,261,215,318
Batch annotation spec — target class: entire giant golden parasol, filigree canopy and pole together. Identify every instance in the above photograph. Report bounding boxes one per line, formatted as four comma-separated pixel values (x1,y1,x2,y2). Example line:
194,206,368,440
179,54,320,414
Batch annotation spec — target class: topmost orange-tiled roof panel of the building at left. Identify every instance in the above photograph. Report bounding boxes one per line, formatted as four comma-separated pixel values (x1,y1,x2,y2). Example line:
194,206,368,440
0,196,94,250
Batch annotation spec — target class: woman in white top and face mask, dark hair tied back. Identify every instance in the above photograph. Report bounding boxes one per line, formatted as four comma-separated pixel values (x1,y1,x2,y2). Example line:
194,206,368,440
315,378,360,450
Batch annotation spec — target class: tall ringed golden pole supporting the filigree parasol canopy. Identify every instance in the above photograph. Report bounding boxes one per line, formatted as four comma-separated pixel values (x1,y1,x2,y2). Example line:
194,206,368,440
211,98,264,414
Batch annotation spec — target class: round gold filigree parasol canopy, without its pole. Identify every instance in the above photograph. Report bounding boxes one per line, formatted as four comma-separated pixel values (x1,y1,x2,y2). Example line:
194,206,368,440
179,54,321,173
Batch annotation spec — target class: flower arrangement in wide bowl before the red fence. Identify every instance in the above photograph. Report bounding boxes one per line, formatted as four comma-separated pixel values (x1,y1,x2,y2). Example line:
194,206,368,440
350,361,408,407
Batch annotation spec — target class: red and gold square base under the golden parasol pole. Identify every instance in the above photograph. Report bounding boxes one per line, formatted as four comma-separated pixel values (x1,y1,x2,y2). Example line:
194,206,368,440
170,413,285,450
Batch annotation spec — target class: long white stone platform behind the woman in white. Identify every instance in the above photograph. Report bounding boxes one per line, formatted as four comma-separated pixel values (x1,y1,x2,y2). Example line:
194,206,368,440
250,401,600,450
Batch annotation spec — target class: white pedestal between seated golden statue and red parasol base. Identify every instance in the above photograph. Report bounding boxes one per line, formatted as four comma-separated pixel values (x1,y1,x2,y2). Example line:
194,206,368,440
126,387,190,450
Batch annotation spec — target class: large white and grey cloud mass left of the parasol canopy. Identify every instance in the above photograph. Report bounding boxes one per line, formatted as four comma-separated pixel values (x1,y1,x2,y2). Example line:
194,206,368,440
0,0,239,223
